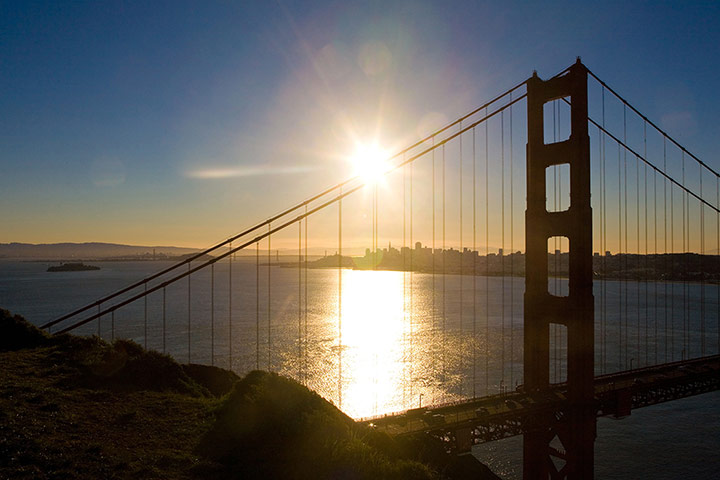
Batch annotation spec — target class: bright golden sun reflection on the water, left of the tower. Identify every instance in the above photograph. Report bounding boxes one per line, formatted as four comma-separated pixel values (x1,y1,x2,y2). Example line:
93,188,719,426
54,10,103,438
268,270,522,418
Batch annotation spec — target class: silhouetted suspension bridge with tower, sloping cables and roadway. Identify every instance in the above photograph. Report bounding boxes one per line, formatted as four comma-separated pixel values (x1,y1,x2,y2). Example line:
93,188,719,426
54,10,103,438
43,60,720,479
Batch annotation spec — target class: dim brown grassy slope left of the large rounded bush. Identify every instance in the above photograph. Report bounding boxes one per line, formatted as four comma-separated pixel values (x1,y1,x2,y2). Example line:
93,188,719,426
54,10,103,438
0,312,217,479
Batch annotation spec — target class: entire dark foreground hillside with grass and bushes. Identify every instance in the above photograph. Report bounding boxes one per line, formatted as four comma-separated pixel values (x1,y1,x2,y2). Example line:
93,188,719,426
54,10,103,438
0,310,497,480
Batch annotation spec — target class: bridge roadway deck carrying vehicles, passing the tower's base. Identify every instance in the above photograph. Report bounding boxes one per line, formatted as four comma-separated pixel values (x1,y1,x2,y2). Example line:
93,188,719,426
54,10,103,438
361,355,720,453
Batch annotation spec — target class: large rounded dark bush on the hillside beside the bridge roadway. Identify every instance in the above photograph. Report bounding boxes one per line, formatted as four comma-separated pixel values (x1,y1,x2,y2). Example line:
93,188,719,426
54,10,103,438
198,371,435,480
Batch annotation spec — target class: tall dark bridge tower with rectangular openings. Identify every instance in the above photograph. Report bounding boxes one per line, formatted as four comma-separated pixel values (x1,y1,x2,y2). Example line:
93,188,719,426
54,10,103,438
523,59,596,480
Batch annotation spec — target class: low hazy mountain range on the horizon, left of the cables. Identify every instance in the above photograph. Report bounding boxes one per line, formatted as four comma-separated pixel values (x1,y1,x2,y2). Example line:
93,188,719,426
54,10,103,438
0,242,200,260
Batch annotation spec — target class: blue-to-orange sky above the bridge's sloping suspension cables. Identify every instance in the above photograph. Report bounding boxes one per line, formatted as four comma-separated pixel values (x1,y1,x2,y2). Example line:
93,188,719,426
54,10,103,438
0,1,720,247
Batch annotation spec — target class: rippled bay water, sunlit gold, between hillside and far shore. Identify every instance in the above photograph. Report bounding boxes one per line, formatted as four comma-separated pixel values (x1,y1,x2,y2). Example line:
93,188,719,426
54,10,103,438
0,258,720,478
